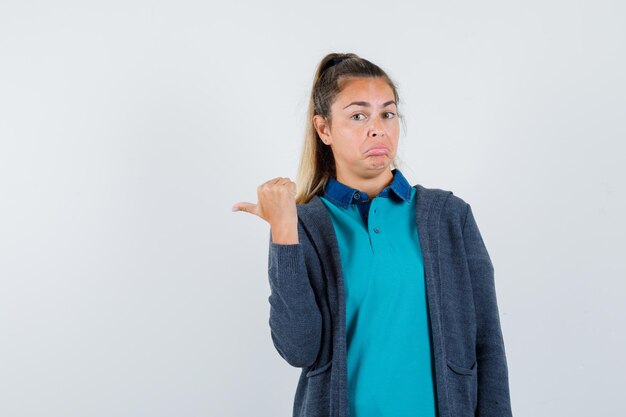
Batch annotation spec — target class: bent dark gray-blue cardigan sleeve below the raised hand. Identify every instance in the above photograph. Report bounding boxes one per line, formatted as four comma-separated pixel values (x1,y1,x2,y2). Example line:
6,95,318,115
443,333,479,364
268,230,322,368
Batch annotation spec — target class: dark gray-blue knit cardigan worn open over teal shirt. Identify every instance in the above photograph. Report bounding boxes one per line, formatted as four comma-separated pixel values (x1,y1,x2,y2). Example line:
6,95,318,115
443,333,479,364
268,184,512,417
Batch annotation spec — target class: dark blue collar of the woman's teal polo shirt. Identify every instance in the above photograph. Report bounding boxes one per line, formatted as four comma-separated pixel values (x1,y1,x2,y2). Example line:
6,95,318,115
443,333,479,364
324,168,411,208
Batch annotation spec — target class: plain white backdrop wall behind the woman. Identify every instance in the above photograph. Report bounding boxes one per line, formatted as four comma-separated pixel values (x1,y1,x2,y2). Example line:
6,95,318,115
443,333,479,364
0,0,626,417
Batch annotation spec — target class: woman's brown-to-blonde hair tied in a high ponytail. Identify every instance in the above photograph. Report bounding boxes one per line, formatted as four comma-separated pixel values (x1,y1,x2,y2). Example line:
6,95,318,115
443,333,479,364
296,53,402,204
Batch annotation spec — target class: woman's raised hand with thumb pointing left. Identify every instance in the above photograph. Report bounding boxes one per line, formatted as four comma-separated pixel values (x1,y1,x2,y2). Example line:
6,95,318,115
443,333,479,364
232,177,298,244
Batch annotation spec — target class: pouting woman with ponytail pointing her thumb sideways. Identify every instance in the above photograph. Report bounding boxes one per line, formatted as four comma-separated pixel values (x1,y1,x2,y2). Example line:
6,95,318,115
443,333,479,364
233,53,512,417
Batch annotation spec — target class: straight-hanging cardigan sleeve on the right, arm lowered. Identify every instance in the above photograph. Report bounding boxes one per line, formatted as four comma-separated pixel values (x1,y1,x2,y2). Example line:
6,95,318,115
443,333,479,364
463,204,512,417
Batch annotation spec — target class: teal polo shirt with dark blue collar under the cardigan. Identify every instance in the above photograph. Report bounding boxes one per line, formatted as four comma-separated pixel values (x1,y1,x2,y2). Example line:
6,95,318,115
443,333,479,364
320,168,436,417
